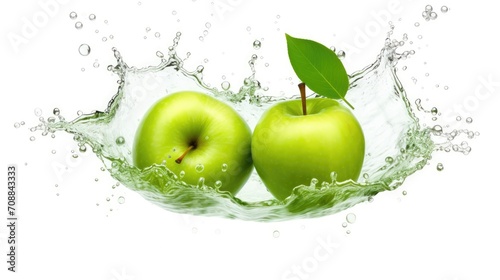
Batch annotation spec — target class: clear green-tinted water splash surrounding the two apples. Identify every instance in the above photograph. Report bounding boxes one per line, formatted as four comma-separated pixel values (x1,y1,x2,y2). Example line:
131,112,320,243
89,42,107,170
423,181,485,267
25,6,476,223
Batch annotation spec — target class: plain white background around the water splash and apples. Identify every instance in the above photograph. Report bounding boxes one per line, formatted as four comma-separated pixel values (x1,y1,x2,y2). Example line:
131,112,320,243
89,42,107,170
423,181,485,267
0,0,500,280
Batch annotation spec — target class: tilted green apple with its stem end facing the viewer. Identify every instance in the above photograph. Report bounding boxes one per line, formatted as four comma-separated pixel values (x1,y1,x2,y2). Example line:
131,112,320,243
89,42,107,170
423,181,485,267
133,91,253,195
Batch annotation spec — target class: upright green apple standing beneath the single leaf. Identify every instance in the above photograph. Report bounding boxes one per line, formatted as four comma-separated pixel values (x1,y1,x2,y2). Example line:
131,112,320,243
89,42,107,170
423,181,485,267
252,98,365,200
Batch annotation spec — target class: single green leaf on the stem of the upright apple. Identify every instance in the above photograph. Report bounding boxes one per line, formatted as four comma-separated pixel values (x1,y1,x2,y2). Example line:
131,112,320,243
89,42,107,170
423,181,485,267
285,34,353,108
